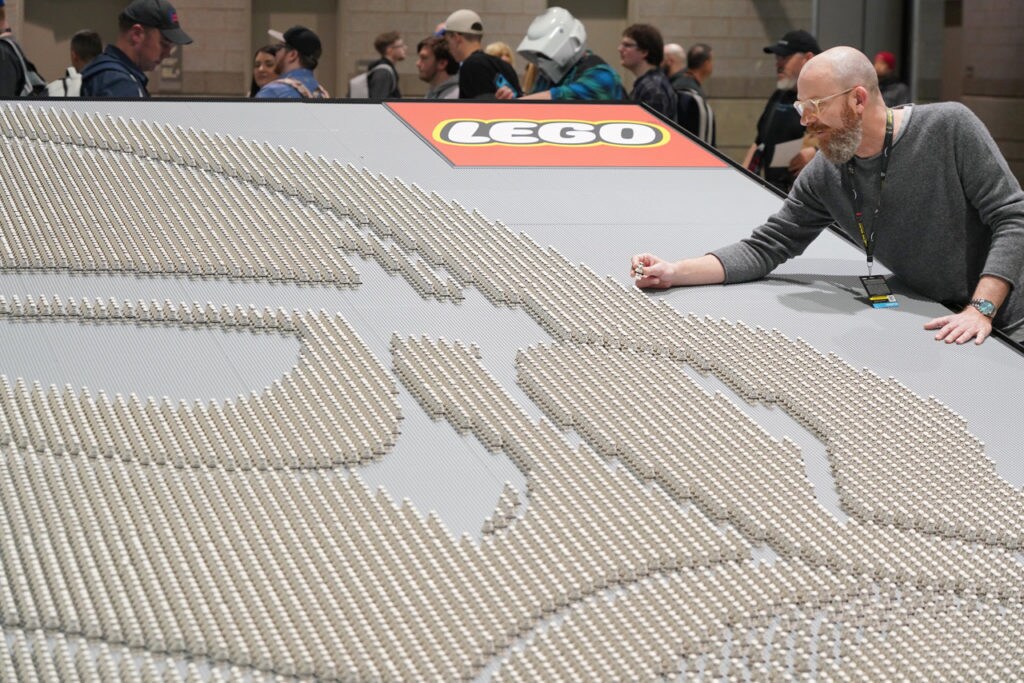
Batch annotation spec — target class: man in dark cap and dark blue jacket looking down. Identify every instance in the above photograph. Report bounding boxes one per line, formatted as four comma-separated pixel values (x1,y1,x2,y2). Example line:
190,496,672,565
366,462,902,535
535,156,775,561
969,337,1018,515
82,0,193,97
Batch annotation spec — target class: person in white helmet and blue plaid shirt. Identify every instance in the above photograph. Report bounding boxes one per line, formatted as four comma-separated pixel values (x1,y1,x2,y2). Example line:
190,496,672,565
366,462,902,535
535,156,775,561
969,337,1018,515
496,7,626,101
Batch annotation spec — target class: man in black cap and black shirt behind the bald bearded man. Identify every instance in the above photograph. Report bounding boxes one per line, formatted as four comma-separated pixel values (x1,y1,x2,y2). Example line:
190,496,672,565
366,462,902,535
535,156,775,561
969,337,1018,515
743,30,821,193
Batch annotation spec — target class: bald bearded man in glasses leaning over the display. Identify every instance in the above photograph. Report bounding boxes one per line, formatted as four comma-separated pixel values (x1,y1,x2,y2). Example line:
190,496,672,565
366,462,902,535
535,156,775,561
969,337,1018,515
631,47,1024,344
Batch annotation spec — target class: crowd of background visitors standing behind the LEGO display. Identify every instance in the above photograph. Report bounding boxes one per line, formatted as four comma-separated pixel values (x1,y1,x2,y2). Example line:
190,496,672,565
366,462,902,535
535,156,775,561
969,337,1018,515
0,0,908,164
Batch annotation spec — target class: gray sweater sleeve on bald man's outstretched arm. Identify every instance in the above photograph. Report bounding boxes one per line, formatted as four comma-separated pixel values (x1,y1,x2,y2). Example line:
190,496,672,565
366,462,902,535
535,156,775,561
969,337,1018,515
711,155,833,283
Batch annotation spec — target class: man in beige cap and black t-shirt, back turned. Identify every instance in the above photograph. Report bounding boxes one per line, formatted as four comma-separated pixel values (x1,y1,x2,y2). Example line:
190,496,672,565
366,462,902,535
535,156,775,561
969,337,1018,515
444,9,522,99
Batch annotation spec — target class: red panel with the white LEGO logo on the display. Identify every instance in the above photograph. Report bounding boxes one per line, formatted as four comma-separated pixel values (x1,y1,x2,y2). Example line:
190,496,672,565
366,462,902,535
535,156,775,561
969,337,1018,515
387,101,726,168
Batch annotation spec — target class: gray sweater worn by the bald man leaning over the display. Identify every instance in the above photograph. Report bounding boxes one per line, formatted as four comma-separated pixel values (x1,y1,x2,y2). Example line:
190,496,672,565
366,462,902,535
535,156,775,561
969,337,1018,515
712,102,1024,328
